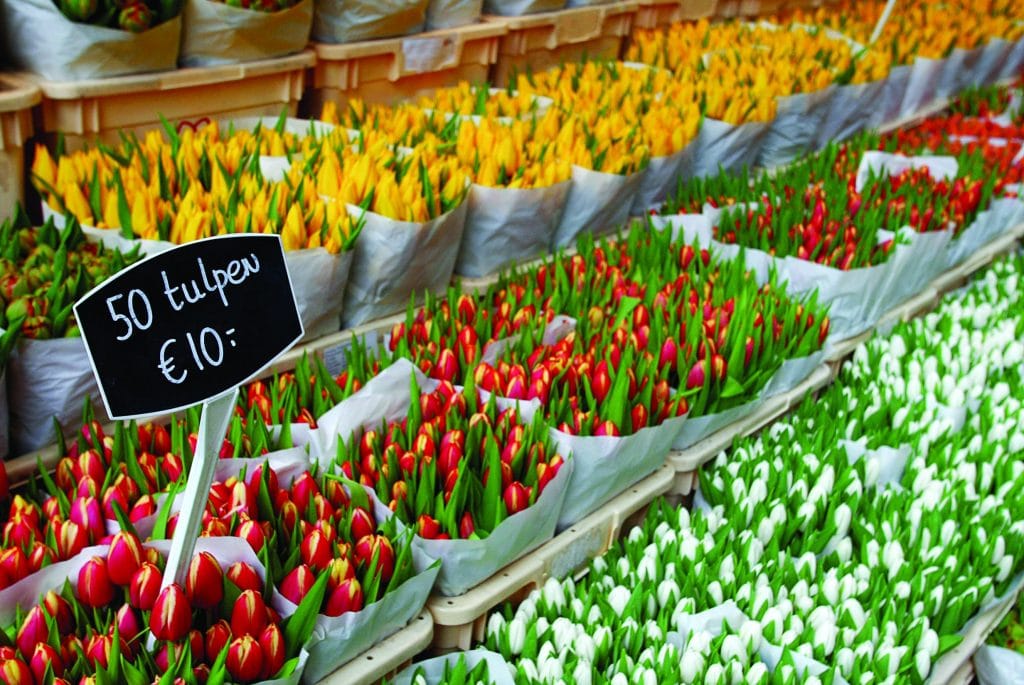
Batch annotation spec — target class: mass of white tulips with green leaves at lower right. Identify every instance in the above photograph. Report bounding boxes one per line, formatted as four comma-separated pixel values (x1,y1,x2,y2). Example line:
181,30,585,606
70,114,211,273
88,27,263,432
450,256,1024,685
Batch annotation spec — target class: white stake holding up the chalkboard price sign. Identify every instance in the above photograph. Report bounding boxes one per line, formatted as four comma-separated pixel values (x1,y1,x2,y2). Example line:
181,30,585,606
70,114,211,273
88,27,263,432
161,389,239,589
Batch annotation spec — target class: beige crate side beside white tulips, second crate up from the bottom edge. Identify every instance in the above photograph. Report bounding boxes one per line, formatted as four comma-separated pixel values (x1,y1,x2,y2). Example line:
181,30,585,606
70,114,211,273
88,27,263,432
427,466,674,652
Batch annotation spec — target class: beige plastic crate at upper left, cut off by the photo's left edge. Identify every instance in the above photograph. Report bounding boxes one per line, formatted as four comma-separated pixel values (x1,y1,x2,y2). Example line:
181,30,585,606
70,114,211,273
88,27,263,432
0,74,40,221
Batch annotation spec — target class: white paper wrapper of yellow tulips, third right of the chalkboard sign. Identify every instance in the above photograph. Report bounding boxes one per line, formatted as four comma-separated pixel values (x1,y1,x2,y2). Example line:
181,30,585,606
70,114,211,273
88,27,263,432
455,180,572,277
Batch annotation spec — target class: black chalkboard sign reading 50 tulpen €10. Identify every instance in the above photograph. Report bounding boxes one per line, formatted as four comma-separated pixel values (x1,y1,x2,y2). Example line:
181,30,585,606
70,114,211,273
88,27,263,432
75,233,303,419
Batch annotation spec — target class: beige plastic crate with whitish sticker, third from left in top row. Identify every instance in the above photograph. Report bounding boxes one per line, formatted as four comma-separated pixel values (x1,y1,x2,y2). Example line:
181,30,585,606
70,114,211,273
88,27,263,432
304,24,505,116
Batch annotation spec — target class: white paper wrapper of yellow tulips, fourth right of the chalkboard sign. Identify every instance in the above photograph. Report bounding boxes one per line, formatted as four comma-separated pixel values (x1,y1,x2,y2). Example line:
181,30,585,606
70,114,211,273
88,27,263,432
551,165,645,250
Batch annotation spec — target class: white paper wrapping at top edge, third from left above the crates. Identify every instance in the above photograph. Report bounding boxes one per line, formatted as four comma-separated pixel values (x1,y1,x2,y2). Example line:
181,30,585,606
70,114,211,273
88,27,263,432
312,0,427,43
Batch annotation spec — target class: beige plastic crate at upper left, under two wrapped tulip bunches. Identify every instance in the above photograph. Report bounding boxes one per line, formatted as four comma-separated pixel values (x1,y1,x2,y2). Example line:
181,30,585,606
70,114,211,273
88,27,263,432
28,50,314,149
